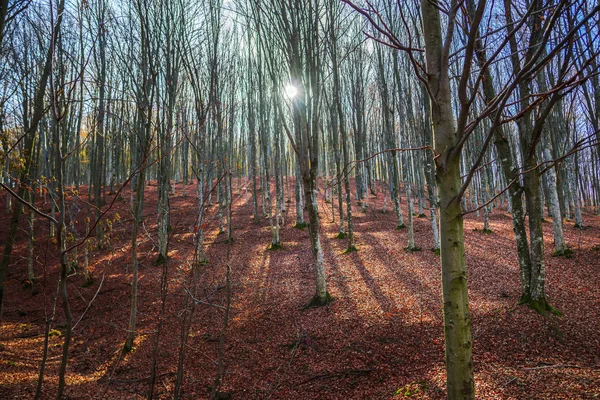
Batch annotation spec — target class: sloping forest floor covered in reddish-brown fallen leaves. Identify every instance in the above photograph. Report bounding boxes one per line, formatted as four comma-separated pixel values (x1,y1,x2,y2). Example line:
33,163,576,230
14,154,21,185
0,180,600,399
